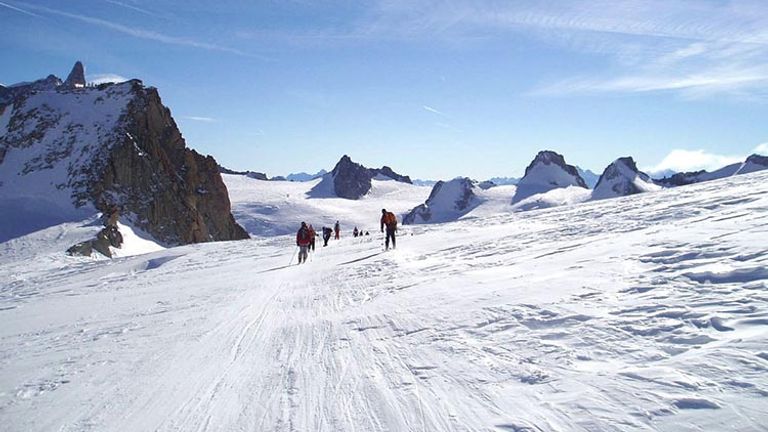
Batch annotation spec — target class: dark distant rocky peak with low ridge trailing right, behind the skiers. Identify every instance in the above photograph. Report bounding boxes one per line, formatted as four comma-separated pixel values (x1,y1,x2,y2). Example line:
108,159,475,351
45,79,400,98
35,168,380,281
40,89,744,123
310,155,411,200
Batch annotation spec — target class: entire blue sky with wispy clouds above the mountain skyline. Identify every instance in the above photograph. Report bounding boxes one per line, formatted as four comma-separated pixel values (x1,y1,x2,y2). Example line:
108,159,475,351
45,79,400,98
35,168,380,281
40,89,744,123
0,0,768,179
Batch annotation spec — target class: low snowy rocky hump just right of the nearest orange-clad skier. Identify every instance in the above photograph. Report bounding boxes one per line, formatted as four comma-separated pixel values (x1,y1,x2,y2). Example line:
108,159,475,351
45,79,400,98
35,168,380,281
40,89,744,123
403,177,482,225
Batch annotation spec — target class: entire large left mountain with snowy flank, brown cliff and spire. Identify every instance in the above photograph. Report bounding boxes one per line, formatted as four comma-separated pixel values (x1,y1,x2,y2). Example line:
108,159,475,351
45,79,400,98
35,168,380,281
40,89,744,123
0,65,248,244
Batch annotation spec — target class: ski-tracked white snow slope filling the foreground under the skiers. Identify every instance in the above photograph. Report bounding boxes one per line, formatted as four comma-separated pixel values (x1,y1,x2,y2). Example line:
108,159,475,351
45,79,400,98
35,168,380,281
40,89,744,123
0,173,768,431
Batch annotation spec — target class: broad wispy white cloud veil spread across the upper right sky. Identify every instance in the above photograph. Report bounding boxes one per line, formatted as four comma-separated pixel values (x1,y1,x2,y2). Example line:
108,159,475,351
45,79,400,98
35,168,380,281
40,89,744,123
350,0,768,97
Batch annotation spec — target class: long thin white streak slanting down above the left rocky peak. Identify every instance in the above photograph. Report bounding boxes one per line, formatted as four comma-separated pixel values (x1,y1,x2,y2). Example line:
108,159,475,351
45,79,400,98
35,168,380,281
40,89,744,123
16,4,262,58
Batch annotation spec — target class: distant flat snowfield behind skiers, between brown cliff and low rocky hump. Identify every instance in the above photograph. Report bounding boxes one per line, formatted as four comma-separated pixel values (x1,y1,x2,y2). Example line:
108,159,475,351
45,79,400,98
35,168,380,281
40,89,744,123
222,174,431,236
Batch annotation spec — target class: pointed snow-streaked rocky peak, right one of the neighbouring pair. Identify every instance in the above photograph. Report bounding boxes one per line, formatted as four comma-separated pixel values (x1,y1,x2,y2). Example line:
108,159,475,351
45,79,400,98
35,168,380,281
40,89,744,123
592,157,661,199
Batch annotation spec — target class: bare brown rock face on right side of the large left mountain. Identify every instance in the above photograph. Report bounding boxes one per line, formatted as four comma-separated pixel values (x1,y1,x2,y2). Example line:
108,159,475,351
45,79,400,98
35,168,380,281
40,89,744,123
91,82,248,244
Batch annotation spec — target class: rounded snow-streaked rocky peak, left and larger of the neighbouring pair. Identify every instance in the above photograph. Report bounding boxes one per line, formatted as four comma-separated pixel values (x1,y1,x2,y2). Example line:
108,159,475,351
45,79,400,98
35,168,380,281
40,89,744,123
512,150,587,204
